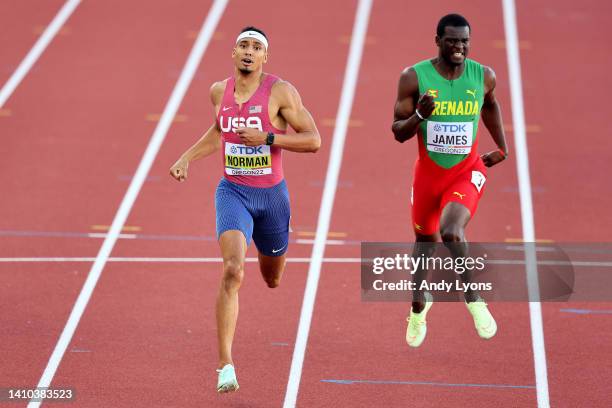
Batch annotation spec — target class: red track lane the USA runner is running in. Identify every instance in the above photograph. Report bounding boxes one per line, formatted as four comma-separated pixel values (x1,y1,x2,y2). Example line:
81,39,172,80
49,2,354,406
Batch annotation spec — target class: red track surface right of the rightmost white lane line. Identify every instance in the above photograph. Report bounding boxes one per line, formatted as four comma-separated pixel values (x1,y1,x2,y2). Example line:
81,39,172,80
517,0,612,407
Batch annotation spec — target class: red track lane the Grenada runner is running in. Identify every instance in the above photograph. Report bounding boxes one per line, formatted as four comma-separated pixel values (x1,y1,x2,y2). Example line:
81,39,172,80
298,2,535,407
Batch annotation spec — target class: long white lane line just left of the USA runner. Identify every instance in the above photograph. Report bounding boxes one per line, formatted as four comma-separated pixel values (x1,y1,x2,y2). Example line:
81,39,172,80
28,0,228,408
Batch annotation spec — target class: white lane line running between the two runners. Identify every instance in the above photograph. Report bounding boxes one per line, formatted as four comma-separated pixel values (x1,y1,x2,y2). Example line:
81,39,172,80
283,0,372,408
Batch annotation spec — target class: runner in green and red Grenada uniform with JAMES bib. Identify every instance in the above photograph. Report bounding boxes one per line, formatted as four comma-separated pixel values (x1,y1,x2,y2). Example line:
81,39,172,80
392,14,508,347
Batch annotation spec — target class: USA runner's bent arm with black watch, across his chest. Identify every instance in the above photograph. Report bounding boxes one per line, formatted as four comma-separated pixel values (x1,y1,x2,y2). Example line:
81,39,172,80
236,81,321,153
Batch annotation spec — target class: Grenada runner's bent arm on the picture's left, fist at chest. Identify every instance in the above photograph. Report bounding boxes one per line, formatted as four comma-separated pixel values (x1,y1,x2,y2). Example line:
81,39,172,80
391,67,434,143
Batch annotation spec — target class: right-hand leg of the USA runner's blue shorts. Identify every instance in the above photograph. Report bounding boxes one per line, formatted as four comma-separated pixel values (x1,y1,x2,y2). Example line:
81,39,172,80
253,180,291,257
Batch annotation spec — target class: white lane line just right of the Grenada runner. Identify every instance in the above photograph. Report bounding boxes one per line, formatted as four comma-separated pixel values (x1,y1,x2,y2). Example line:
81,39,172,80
502,0,550,408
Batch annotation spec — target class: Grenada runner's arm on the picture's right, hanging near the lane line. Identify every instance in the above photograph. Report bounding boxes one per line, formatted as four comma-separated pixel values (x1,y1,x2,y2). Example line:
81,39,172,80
480,67,508,167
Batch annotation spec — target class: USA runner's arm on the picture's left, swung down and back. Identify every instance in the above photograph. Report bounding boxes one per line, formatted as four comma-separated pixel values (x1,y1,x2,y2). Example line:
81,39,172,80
170,82,225,181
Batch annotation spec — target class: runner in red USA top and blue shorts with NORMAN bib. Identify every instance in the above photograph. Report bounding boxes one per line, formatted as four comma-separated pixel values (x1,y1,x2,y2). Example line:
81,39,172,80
170,27,321,392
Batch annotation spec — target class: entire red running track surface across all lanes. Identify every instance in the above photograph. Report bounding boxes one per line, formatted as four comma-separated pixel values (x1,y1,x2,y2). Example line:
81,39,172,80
0,0,612,407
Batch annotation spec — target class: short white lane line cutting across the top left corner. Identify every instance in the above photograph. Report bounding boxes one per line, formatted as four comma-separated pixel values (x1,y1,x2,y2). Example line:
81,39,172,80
0,0,81,108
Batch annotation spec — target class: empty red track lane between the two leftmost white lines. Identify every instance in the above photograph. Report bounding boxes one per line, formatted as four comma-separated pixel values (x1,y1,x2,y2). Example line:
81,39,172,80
0,1,220,398
